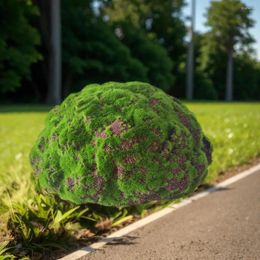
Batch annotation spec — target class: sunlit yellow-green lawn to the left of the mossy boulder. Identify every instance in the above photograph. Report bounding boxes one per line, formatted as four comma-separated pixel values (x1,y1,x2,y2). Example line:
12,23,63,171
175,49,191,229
0,107,47,207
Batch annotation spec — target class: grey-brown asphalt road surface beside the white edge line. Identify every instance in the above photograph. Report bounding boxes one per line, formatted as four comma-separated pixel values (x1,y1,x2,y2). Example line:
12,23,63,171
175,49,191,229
82,171,260,260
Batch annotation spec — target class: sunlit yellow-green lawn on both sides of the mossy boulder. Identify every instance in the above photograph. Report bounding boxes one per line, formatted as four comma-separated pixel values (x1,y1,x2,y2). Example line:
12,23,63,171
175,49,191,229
0,103,260,256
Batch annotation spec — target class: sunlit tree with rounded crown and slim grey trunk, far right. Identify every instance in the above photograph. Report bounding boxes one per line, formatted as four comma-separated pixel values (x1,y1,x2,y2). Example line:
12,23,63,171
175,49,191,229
206,0,254,101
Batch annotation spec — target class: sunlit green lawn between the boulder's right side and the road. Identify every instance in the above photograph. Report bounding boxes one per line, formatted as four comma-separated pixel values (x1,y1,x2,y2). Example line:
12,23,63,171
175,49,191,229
187,103,260,183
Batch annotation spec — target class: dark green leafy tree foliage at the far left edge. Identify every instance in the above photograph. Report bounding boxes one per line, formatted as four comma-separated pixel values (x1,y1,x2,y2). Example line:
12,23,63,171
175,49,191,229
0,0,42,93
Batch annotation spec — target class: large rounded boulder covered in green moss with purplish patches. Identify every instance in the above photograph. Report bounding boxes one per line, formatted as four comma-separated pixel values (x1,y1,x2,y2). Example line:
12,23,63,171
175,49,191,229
31,82,211,206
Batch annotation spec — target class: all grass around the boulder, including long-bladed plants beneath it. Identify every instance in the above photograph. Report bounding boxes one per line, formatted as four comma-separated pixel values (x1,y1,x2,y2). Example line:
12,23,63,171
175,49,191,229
0,103,260,259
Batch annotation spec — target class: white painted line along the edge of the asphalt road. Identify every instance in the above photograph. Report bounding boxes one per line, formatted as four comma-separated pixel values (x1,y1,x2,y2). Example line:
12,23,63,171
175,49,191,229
60,164,260,260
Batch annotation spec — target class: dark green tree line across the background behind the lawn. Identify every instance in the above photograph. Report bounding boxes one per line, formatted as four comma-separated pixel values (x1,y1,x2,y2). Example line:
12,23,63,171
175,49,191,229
0,0,260,102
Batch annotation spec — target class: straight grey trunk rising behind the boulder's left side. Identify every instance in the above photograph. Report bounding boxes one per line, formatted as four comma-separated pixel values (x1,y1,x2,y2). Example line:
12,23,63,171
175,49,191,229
47,0,61,105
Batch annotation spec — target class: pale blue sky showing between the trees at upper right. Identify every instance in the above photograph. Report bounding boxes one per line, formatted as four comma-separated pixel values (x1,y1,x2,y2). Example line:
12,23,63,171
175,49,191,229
184,0,260,60
